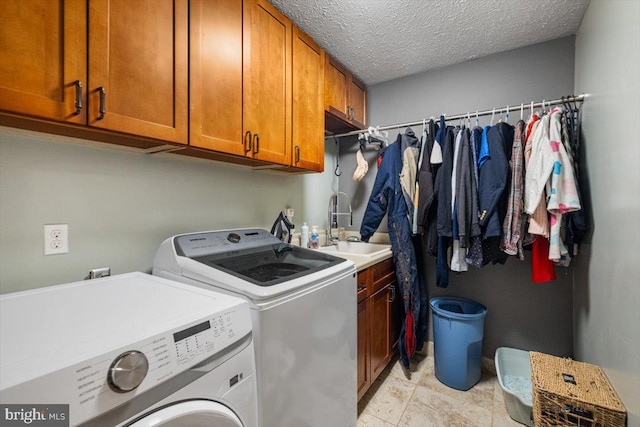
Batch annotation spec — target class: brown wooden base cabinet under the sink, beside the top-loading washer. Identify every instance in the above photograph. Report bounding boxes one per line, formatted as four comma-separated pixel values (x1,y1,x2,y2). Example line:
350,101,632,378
357,259,400,399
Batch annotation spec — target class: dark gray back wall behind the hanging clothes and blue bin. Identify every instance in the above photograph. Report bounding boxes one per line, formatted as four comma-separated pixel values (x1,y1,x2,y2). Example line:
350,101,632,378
340,37,575,356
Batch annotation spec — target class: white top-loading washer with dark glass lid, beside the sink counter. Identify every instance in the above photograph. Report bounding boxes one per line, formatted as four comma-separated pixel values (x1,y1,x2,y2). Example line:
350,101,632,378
153,229,358,427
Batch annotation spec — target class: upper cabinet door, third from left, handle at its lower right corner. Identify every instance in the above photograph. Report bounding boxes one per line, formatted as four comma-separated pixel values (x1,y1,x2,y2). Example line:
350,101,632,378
189,0,245,156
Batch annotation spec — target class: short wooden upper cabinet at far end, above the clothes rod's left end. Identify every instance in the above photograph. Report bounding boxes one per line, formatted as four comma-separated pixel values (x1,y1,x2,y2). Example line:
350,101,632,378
324,55,367,132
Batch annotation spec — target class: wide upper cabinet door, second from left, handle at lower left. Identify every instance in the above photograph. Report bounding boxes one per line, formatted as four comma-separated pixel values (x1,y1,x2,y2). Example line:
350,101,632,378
89,0,188,143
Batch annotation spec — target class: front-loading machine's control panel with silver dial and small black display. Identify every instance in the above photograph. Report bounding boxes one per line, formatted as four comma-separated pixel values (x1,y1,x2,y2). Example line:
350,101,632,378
2,303,251,425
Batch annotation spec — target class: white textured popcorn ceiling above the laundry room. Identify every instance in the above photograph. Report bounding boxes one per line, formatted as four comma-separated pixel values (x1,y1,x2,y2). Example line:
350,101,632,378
271,0,589,86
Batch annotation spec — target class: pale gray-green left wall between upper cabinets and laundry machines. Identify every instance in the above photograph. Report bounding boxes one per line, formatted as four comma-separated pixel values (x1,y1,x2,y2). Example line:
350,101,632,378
0,127,337,293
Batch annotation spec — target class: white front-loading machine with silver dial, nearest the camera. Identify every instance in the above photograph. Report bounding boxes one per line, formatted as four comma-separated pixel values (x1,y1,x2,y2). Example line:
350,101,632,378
0,273,258,427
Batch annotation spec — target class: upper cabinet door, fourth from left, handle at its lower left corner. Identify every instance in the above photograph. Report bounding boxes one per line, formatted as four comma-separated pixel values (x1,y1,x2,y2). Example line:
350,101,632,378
243,0,292,165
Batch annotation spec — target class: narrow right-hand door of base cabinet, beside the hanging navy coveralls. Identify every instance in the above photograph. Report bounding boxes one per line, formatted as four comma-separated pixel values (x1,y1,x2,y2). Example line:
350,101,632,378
369,286,391,378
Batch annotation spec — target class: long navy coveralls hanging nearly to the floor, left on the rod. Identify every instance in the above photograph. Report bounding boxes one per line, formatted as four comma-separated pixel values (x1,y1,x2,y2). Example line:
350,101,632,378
360,143,427,369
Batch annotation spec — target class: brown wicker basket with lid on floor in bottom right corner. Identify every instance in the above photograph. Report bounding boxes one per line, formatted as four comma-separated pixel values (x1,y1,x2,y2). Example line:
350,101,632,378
530,352,627,427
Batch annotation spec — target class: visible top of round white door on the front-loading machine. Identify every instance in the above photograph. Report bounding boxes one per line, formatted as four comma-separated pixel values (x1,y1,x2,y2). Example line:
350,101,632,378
127,400,243,427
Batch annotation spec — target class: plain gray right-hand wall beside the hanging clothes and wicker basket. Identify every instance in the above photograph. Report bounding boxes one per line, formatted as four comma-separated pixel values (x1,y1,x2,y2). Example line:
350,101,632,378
574,0,640,427
